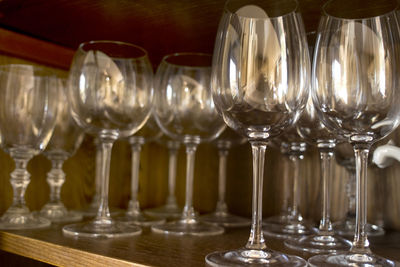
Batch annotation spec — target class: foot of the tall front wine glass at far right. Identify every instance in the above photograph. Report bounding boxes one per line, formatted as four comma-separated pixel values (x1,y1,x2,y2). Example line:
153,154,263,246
308,252,399,267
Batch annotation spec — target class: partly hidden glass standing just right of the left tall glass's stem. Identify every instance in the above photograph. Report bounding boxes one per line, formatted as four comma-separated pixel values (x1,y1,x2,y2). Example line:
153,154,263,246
263,139,314,239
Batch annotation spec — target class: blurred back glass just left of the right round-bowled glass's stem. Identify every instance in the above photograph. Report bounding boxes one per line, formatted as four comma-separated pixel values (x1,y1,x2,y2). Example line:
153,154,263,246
144,137,182,219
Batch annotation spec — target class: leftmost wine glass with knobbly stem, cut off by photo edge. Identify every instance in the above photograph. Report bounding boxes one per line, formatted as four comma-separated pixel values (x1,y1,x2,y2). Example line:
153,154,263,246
0,64,59,230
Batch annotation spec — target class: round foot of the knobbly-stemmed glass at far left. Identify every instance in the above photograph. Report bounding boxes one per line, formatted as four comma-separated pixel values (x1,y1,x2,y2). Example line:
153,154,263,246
0,211,51,230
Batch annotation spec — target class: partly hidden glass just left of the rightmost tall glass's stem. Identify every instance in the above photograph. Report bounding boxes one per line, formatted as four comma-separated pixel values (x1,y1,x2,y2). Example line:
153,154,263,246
285,90,351,253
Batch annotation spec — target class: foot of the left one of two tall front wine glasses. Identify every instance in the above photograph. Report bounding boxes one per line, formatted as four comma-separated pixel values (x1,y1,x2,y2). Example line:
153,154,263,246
206,248,307,267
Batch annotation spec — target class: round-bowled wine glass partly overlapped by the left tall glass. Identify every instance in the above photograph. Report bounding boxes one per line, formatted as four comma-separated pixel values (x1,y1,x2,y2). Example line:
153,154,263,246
151,53,225,236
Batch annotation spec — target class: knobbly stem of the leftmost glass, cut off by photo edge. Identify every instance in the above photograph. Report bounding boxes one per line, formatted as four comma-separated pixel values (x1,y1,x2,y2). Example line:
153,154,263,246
7,151,33,213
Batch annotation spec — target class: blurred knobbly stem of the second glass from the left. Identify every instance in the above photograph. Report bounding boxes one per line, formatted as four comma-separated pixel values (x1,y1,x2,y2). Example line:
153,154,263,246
46,158,65,204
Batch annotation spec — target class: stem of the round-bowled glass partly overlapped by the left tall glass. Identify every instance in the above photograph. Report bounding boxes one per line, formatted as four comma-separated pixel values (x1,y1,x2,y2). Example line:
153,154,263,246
182,142,198,223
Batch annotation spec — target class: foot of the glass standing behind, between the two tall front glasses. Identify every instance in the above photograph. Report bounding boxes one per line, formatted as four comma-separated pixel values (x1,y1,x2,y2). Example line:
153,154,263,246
285,235,351,254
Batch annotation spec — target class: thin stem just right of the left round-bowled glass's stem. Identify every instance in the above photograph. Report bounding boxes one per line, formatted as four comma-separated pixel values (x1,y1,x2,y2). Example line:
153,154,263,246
127,136,144,215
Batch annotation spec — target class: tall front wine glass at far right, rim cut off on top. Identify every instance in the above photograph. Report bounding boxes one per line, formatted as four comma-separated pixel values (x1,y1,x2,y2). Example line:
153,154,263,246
309,0,400,266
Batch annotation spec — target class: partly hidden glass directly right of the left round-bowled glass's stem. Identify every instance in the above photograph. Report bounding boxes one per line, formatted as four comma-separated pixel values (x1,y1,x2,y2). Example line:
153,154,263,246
116,117,165,226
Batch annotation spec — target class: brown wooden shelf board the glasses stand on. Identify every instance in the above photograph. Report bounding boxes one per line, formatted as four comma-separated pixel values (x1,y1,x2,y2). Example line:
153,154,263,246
0,225,400,267
